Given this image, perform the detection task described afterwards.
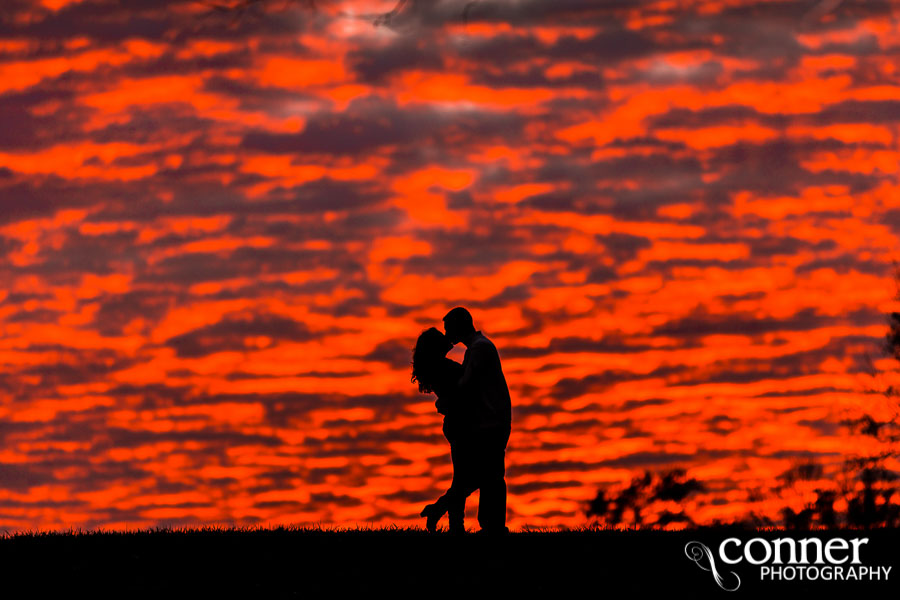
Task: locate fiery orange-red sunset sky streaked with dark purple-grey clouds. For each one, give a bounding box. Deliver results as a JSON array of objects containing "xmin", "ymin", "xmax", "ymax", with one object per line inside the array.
[{"xmin": 0, "ymin": 0, "xmax": 900, "ymax": 531}]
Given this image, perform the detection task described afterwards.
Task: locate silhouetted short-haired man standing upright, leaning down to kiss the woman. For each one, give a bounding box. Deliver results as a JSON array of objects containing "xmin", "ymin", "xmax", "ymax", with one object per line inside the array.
[{"xmin": 444, "ymin": 306, "xmax": 512, "ymax": 534}]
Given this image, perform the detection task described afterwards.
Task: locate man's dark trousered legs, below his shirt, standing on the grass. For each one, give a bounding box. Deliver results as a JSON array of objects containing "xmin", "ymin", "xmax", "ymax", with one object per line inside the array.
[{"xmin": 478, "ymin": 430, "xmax": 509, "ymax": 532}]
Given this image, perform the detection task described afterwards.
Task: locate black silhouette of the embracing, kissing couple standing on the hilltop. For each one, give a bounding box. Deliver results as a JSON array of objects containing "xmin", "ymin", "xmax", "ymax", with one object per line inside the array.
[{"xmin": 412, "ymin": 306, "xmax": 512, "ymax": 534}]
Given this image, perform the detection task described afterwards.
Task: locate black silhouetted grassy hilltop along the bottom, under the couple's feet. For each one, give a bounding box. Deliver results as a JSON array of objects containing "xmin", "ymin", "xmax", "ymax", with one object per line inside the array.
[{"xmin": 0, "ymin": 527, "xmax": 900, "ymax": 598}]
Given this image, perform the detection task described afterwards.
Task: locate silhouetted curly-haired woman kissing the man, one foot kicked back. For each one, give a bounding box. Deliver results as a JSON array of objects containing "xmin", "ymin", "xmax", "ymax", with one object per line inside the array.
[{"xmin": 411, "ymin": 327, "xmax": 474, "ymax": 533}]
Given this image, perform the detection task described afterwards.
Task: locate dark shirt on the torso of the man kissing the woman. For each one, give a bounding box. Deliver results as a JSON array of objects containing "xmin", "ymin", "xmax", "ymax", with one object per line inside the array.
[{"xmin": 459, "ymin": 331, "xmax": 512, "ymax": 428}]
